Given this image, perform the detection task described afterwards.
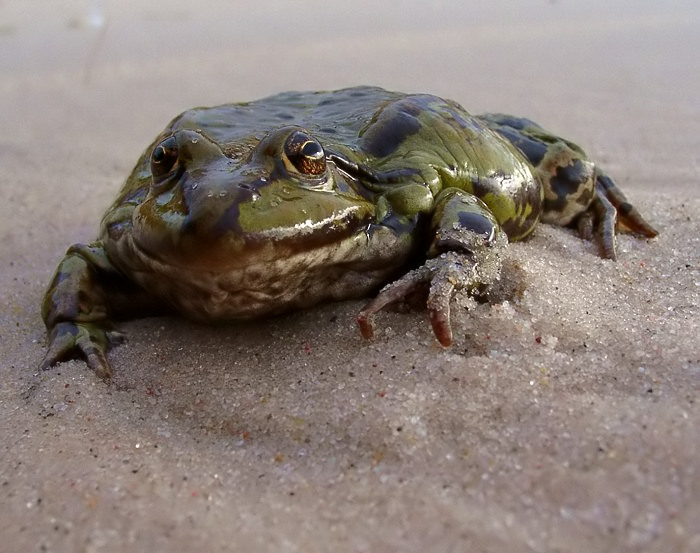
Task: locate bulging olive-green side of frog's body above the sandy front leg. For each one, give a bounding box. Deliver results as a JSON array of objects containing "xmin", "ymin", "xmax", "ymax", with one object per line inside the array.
[{"xmin": 340, "ymin": 90, "xmax": 543, "ymax": 240}]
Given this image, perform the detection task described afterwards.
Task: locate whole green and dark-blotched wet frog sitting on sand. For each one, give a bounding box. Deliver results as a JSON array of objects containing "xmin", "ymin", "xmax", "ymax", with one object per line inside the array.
[{"xmin": 41, "ymin": 86, "xmax": 657, "ymax": 379}]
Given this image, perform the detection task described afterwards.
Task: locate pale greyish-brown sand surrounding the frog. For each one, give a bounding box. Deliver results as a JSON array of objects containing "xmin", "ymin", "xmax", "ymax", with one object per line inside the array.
[{"xmin": 0, "ymin": 0, "xmax": 700, "ymax": 552}]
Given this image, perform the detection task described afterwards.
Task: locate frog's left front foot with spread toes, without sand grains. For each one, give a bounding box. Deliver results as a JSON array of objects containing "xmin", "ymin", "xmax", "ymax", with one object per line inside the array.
[{"xmin": 41, "ymin": 321, "xmax": 124, "ymax": 379}]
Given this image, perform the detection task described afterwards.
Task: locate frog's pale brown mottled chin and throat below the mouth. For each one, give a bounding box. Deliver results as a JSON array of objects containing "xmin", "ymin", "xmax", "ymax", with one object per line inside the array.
[{"xmin": 124, "ymin": 226, "xmax": 405, "ymax": 322}]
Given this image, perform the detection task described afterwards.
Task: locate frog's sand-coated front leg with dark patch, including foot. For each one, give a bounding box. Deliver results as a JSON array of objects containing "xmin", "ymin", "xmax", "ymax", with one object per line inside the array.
[{"xmin": 357, "ymin": 188, "xmax": 508, "ymax": 346}]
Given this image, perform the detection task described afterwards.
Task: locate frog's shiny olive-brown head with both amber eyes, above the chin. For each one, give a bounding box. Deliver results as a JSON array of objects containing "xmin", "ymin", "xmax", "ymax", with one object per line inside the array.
[{"xmin": 133, "ymin": 126, "xmax": 374, "ymax": 268}]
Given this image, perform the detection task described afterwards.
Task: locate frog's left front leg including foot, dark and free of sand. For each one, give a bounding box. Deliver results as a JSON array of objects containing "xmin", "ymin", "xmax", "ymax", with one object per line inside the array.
[{"xmin": 41, "ymin": 241, "xmax": 155, "ymax": 378}]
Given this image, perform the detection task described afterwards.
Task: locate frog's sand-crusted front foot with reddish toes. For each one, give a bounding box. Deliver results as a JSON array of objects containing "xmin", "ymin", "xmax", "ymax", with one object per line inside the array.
[{"xmin": 357, "ymin": 239, "xmax": 505, "ymax": 347}]
